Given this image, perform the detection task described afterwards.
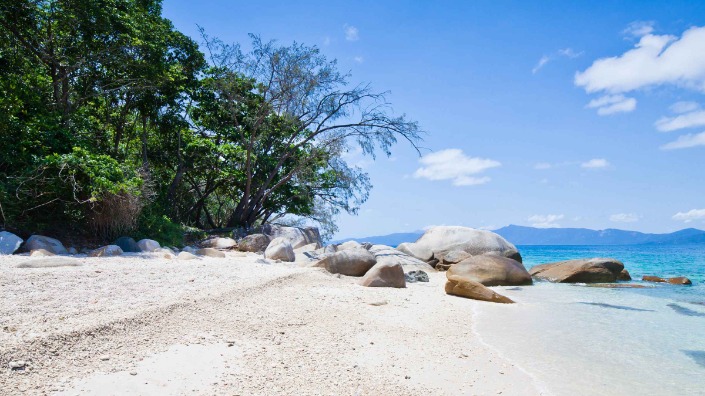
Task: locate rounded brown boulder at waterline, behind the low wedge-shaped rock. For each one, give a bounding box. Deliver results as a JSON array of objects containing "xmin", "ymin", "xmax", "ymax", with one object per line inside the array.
[{"xmin": 446, "ymin": 255, "xmax": 532, "ymax": 286}]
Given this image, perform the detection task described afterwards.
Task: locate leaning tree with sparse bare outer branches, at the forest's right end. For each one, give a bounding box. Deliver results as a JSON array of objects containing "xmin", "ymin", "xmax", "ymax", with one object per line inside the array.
[{"xmin": 188, "ymin": 30, "xmax": 421, "ymax": 232}]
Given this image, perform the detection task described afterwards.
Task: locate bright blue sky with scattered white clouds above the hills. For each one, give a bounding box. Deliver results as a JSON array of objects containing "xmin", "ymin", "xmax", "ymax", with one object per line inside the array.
[{"xmin": 164, "ymin": 0, "xmax": 705, "ymax": 238}]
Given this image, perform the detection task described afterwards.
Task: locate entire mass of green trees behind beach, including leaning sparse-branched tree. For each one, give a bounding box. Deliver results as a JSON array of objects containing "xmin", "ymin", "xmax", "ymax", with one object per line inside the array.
[{"xmin": 0, "ymin": 0, "xmax": 421, "ymax": 245}]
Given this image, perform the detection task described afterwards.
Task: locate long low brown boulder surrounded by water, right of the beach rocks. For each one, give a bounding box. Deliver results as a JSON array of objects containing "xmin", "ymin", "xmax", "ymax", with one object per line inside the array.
[{"xmin": 529, "ymin": 258, "xmax": 624, "ymax": 283}]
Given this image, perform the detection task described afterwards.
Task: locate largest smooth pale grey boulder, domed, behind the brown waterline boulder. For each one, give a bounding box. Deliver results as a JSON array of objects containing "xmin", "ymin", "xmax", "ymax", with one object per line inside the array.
[{"xmin": 397, "ymin": 226, "xmax": 521, "ymax": 262}]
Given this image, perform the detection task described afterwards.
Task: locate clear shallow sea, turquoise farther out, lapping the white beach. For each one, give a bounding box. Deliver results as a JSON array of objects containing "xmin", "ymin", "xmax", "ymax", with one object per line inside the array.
[{"xmin": 473, "ymin": 245, "xmax": 705, "ymax": 395}]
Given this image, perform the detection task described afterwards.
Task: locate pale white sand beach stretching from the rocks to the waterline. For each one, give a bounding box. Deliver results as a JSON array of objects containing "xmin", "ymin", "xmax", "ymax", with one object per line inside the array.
[{"xmin": 0, "ymin": 254, "xmax": 540, "ymax": 396}]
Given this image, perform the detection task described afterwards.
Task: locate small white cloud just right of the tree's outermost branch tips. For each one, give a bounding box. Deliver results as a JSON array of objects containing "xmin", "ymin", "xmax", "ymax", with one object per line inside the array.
[{"xmin": 414, "ymin": 149, "xmax": 502, "ymax": 186}]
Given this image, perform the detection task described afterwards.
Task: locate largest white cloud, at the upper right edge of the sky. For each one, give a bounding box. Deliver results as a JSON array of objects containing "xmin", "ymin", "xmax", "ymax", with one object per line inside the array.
[{"xmin": 575, "ymin": 27, "xmax": 705, "ymax": 94}]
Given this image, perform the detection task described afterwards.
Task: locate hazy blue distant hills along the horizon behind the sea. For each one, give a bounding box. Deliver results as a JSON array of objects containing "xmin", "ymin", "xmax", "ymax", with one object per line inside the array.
[{"xmin": 334, "ymin": 225, "xmax": 705, "ymax": 246}]
